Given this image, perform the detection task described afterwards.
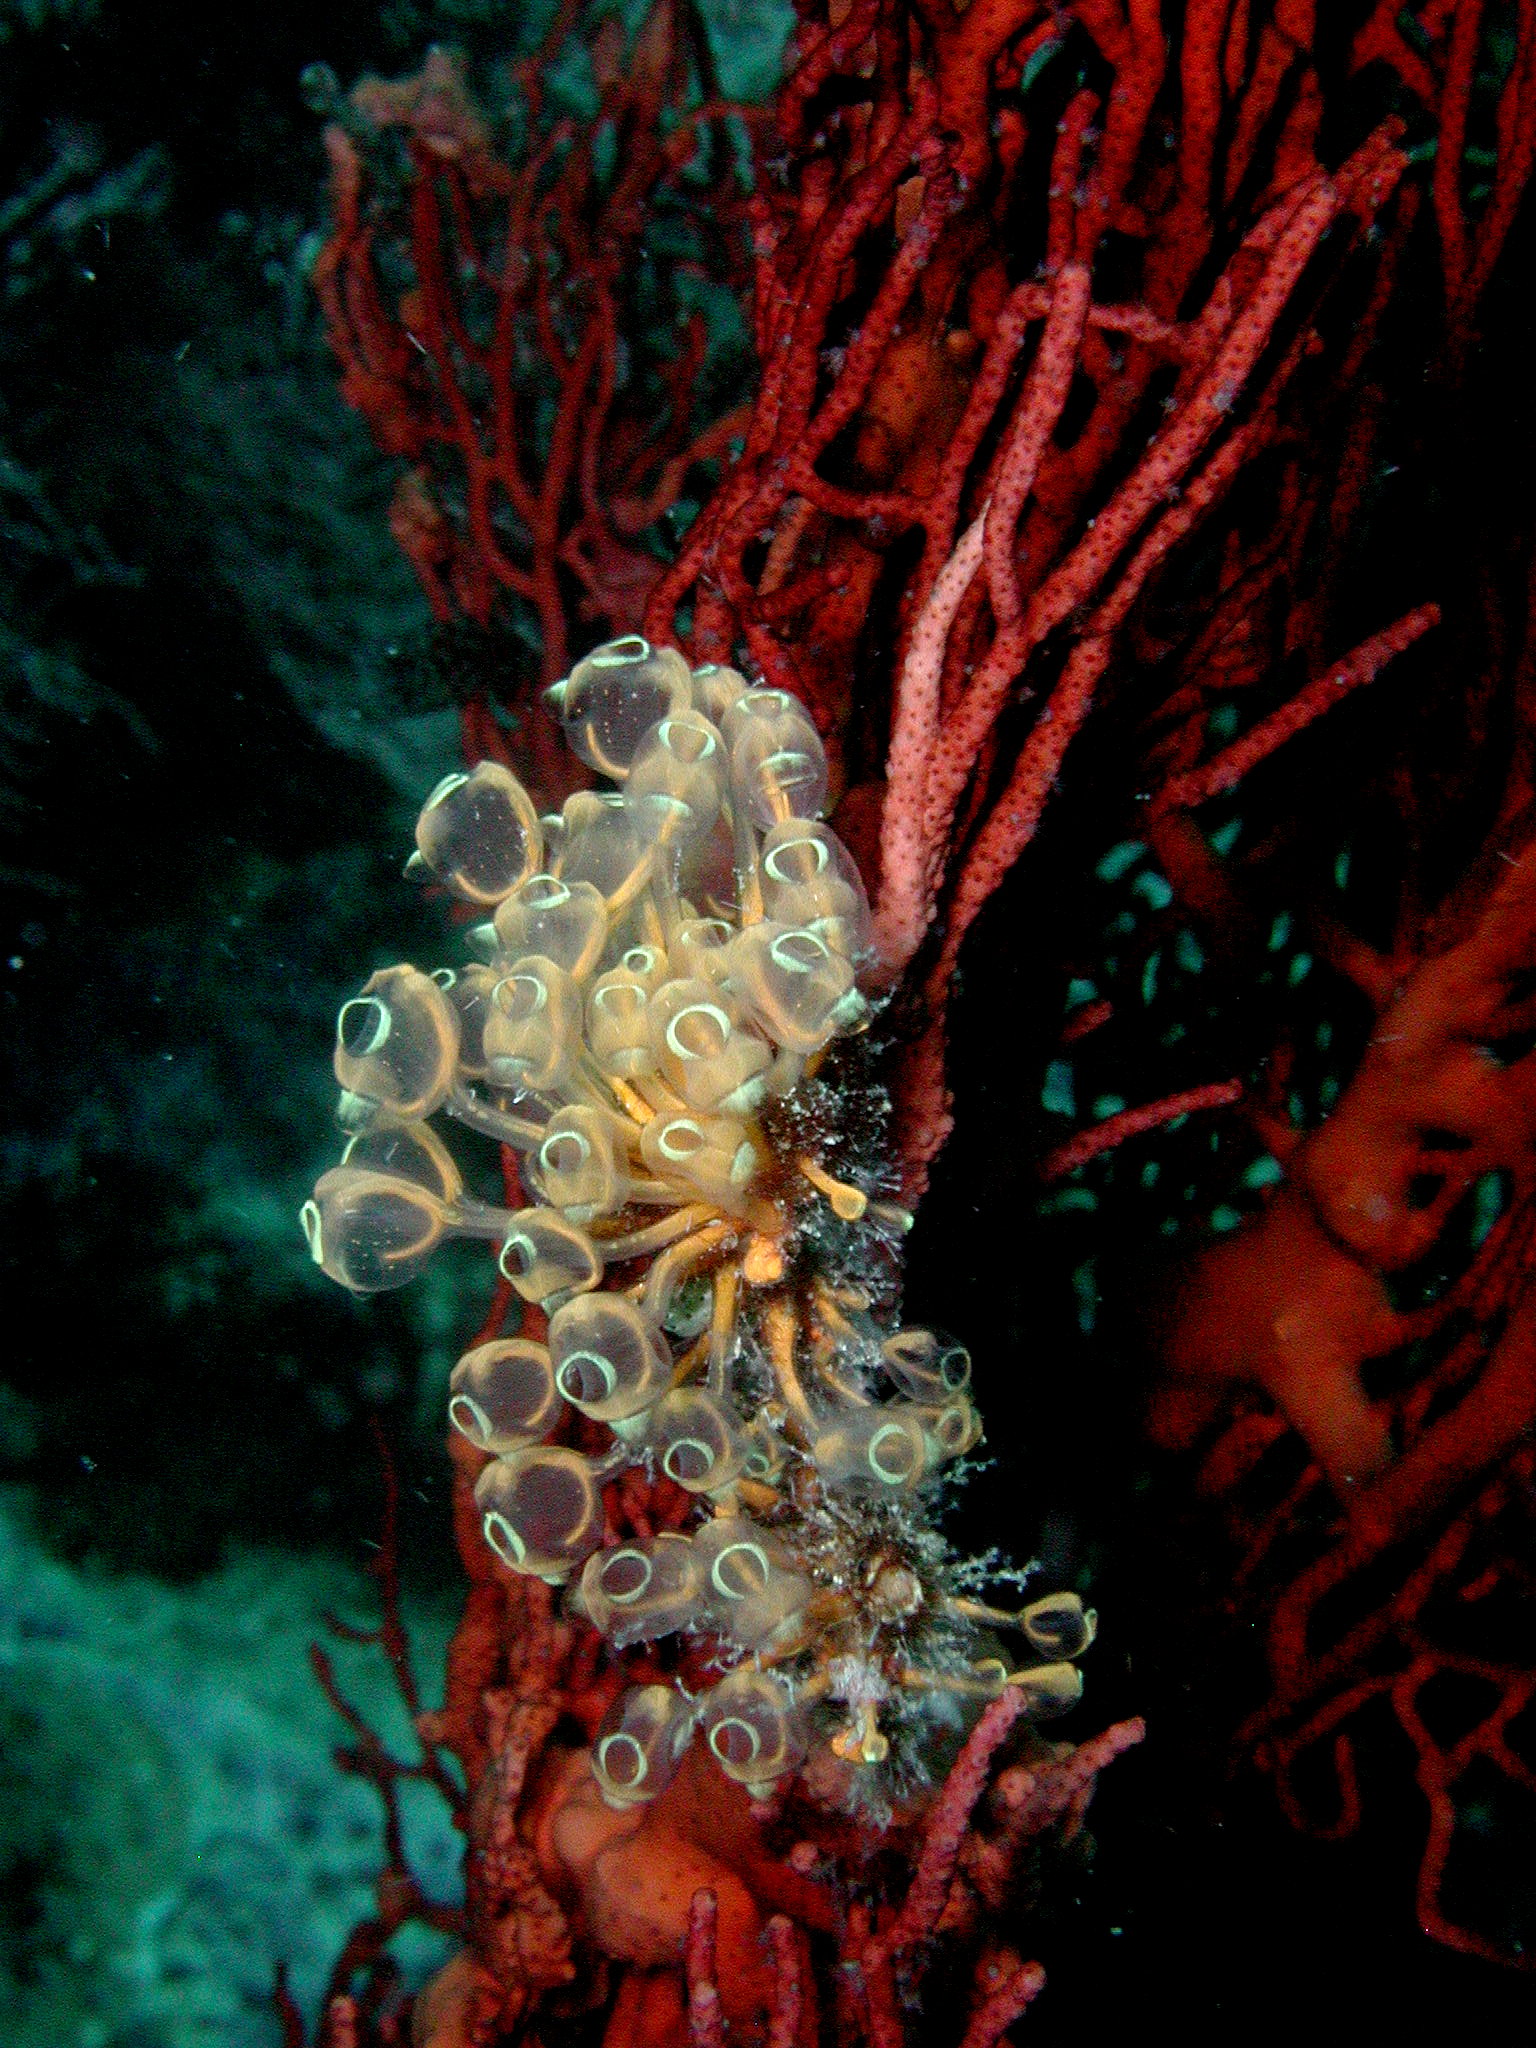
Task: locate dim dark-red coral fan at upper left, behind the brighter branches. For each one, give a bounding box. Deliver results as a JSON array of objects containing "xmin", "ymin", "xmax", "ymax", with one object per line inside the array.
[{"xmin": 315, "ymin": 22, "xmax": 754, "ymax": 788}]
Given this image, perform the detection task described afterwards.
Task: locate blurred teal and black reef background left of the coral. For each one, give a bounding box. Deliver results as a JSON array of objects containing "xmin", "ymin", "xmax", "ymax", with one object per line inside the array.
[{"xmin": 0, "ymin": 0, "xmax": 786, "ymax": 2048}]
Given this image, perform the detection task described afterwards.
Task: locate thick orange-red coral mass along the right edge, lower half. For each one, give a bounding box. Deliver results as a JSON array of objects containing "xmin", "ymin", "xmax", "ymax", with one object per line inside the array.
[{"xmin": 1153, "ymin": 761, "xmax": 1536, "ymax": 1960}]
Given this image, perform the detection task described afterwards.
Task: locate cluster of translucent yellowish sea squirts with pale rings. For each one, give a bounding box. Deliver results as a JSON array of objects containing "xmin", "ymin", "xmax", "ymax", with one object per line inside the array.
[{"xmin": 303, "ymin": 637, "xmax": 1094, "ymax": 1806}]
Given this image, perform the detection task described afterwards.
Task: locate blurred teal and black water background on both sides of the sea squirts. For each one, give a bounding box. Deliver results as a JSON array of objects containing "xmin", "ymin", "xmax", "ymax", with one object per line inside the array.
[{"xmin": 0, "ymin": 0, "xmax": 1536, "ymax": 2048}]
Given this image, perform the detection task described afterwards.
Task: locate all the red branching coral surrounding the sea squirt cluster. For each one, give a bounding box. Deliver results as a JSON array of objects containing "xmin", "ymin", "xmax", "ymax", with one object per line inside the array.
[{"xmin": 303, "ymin": 0, "xmax": 1536, "ymax": 2023}]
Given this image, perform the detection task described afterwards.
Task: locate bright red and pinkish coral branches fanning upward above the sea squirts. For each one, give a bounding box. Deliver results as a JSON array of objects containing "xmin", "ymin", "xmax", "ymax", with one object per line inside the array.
[{"xmin": 647, "ymin": 6, "xmax": 1466, "ymax": 1194}]
